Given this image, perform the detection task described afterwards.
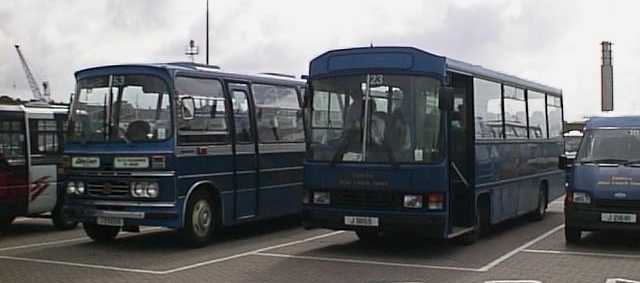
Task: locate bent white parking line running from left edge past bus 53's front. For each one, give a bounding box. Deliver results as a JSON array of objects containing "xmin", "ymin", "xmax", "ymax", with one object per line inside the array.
[{"xmin": 0, "ymin": 231, "xmax": 344, "ymax": 275}]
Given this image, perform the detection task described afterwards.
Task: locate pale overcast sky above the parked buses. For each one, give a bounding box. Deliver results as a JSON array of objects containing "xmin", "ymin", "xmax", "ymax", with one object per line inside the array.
[{"xmin": 0, "ymin": 0, "xmax": 640, "ymax": 120}]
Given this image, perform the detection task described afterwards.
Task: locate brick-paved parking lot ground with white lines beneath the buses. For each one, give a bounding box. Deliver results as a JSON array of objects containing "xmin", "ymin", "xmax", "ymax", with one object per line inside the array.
[{"xmin": 0, "ymin": 201, "xmax": 640, "ymax": 283}]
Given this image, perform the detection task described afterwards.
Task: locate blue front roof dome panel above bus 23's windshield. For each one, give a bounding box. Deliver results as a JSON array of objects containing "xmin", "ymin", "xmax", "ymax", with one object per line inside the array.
[{"xmin": 309, "ymin": 47, "xmax": 446, "ymax": 80}]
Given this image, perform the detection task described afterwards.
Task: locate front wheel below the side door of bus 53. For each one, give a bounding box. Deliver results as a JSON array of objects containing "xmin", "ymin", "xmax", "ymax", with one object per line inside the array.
[{"xmin": 180, "ymin": 191, "xmax": 217, "ymax": 247}]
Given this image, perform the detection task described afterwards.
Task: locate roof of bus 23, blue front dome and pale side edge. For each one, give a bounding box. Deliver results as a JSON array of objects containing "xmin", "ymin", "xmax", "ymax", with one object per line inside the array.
[{"xmin": 309, "ymin": 47, "xmax": 562, "ymax": 95}]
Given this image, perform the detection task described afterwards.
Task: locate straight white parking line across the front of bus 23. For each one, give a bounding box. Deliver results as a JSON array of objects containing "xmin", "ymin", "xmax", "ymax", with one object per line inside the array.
[{"xmin": 254, "ymin": 253, "xmax": 482, "ymax": 272}]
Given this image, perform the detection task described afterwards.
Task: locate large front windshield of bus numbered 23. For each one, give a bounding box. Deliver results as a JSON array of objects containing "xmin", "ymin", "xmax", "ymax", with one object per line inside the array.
[{"xmin": 309, "ymin": 74, "xmax": 443, "ymax": 163}]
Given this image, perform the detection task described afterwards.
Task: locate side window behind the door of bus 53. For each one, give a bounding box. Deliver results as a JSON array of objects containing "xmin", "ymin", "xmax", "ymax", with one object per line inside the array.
[{"xmin": 252, "ymin": 84, "xmax": 304, "ymax": 143}]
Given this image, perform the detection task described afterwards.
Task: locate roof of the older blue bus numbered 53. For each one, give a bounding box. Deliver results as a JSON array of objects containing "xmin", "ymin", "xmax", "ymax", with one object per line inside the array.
[{"xmin": 75, "ymin": 62, "xmax": 305, "ymax": 84}]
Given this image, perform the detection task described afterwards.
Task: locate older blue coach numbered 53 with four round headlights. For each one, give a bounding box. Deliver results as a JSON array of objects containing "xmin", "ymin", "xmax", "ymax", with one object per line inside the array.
[{"xmin": 64, "ymin": 63, "xmax": 305, "ymax": 246}]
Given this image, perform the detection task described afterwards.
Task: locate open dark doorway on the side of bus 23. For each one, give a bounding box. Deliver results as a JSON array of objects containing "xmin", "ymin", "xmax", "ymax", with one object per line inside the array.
[{"xmin": 448, "ymin": 74, "xmax": 475, "ymax": 231}]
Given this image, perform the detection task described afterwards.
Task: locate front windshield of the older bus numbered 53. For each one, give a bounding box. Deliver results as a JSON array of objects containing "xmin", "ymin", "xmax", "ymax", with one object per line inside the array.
[{"xmin": 68, "ymin": 75, "xmax": 172, "ymax": 143}]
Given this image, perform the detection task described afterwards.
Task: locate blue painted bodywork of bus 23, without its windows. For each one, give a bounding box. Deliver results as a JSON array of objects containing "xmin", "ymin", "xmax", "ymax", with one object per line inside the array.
[{"xmin": 303, "ymin": 47, "xmax": 564, "ymax": 237}]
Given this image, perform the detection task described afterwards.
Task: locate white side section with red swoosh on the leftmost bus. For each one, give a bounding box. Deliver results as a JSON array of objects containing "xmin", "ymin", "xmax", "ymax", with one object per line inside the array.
[{"xmin": 27, "ymin": 112, "xmax": 62, "ymax": 214}]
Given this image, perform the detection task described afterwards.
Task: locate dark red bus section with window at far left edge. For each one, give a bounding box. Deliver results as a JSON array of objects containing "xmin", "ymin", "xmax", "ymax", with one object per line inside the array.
[{"xmin": 0, "ymin": 110, "xmax": 29, "ymax": 216}]
